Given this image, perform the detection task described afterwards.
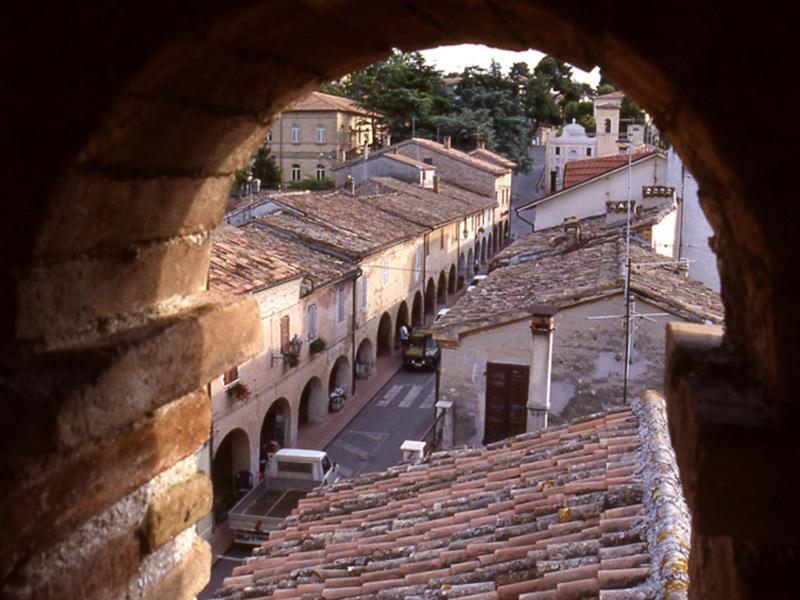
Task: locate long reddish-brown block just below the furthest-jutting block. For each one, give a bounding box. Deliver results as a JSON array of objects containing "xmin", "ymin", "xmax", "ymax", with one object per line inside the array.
[{"xmin": 0, "ymin": 392, "xmax": 211, "ymax": 575}]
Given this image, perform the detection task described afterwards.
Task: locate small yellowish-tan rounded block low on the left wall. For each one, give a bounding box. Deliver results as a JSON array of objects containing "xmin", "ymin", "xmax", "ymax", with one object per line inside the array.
[{"xmin": 140, "ymin": 473, "xmax": 213, "ymax": 552}]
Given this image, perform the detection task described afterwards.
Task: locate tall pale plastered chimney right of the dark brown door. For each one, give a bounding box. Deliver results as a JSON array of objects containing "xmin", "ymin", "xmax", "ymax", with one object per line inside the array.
[{"xmin": 527, "ymin": 306, "xmax": 557, "ymax": 432}]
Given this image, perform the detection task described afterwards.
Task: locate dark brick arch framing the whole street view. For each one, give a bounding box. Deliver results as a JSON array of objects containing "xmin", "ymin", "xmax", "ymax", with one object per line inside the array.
[{"xmin": 0, "ymin": 0, "xmax": 800, "ymax": 595}]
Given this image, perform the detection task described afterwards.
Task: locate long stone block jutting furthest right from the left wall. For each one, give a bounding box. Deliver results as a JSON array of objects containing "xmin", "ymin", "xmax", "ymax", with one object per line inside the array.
[{"xmin": 0, "ymin": 293, "xmax": 263, "ymax": 465}]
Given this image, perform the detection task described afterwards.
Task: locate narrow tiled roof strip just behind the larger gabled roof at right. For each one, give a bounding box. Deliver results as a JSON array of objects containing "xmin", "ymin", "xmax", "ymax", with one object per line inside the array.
[{"xmin": 492, "ymin": 203, "xmax": 676, "ymax": 266}]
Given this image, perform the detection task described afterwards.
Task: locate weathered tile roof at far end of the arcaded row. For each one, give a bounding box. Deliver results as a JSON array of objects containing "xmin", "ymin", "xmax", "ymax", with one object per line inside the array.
[{"xmin": 358, "ymin": 177, "xmax": 496, "ymax": 227}]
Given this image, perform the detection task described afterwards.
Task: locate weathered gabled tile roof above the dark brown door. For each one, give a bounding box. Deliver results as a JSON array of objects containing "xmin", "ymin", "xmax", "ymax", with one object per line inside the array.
[{"xmin": 433, "ymin": 238, "xmax": 724, "ymax": 339}]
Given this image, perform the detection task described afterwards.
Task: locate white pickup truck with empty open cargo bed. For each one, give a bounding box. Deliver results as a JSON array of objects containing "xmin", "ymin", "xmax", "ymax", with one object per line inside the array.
[{"xmin": 228, "ymin": 448, "xmax": 339, "ymax": 545}]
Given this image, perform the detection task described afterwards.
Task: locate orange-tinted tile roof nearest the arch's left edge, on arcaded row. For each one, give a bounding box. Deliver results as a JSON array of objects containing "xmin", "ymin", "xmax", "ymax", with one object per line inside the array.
[{"xmin": 208, "ymin": 224, "xmax": 303, "ymax": 294}]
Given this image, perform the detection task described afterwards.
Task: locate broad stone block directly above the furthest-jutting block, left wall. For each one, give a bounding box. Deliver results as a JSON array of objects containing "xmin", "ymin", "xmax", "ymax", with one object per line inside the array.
[{"xmin": 16, "ymin": 234, "xmax": 211, "ymax": 340}]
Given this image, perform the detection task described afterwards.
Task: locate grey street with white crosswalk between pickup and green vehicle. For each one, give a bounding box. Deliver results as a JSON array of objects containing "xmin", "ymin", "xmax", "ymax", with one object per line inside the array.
[{"xmin": 326, "ymin": 369, "xmax": 436, "ymax": 477}]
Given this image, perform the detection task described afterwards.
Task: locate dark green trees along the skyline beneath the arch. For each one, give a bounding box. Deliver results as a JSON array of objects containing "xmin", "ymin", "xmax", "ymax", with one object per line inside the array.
[{"xmin": 324, "ymin": 51, "xmax": 624, "ymax": 173}]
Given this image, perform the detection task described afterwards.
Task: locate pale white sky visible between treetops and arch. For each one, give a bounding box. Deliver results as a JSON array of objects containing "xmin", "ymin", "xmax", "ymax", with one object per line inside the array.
[{"xmin": 421, "ymin": 44, "xmax": 600, "ymax": 87}]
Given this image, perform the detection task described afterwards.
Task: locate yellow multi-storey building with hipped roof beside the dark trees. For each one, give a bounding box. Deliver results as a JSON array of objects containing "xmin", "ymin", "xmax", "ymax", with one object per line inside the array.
[{"xmin": 267, "ymin": 92, "xmax": 379, "ymax": 182}]
